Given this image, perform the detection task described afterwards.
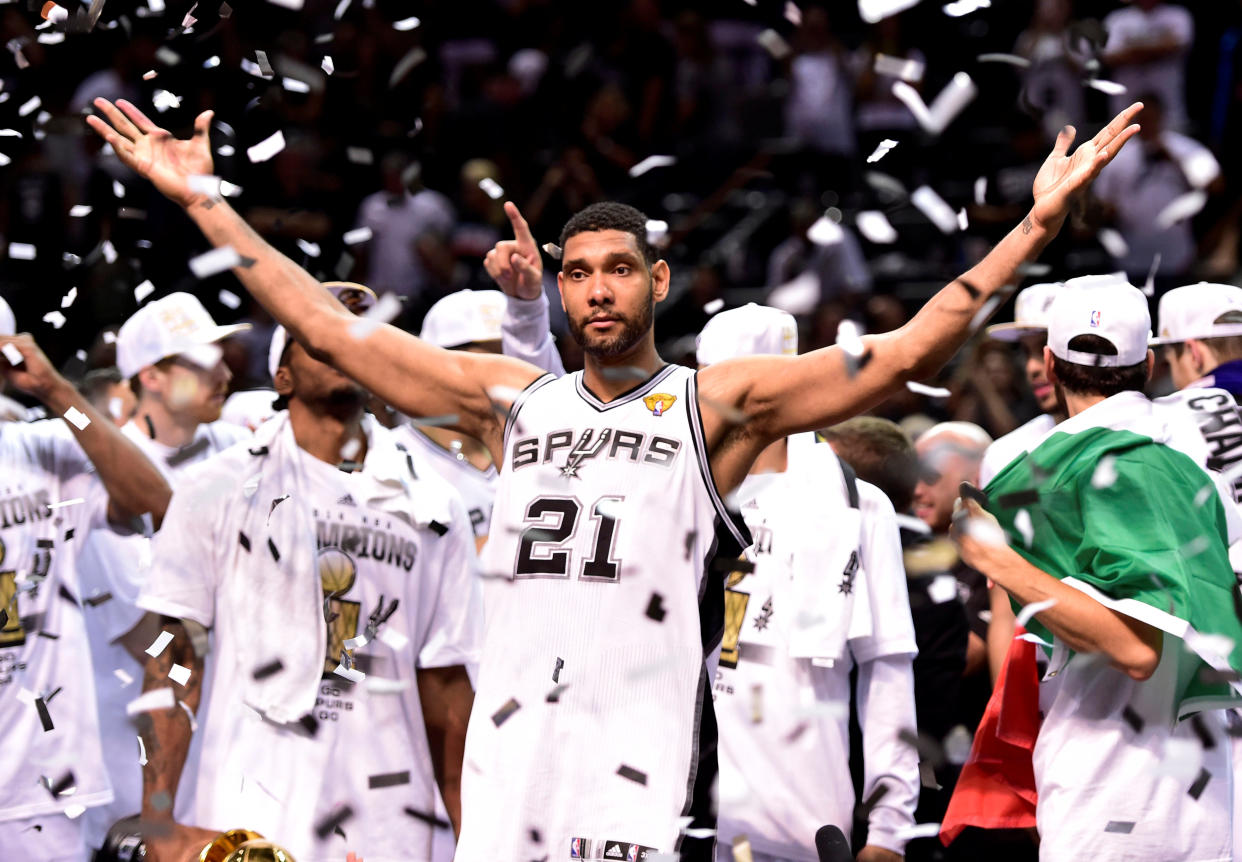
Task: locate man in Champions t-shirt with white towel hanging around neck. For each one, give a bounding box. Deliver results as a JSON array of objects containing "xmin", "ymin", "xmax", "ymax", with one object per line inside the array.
[{"xmin": 138, "ymin": 320, "xmax": 482, "ymax": 862}]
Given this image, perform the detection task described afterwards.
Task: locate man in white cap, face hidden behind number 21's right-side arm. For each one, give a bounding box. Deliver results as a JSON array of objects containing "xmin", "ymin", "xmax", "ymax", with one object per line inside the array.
[{"xmin": 698, "ymin": 304, "xmax": 919, "ymax": 862}]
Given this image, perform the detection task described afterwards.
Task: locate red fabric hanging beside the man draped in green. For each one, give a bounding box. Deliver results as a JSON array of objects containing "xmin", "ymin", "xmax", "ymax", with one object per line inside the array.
[{"xmin": 940, "ymin": 626, "xmax": 1040, "ymax": 847}]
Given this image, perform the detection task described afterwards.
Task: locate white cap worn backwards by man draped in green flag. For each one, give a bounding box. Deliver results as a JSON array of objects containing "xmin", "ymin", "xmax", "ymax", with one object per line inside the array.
[{"xmin": 1048, "ymin": 276, "xmax": 1151, "ymax": 368}]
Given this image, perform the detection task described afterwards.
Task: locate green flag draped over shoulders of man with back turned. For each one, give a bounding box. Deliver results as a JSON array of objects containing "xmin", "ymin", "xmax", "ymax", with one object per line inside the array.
[{"xmin": 986, "ymin": 424, "xmax": 1242, "ymax": 717}]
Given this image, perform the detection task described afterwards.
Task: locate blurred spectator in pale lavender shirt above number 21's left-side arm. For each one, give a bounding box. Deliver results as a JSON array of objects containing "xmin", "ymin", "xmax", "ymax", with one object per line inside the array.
[{"xmin": 356, "ymin": 153, "xmax": 456, "ymax": 315}]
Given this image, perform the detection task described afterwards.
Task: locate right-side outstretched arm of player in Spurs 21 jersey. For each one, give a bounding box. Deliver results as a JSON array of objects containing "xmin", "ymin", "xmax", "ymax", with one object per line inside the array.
[{"xmin": 699, "ymin": 102, "xmax": 1143, "ymax": 492}]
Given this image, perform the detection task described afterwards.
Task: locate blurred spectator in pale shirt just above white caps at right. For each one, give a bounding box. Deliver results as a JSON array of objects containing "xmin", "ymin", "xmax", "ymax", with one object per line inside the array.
[{"xmin": 1094, "ymin": 92, "xmax": 1223, "ymax": 284}]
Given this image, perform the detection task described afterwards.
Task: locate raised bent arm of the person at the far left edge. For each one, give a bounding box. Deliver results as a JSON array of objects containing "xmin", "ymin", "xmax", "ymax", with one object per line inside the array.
[{"xmin": 0, "ymin": 333, "xmax": 173, "ymax": 525}]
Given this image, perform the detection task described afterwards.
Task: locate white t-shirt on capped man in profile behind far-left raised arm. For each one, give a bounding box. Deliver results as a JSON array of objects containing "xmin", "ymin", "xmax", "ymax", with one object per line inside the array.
[{"xmin": 78, "ymin": 420, "xmax": 250, "ymax": 848}]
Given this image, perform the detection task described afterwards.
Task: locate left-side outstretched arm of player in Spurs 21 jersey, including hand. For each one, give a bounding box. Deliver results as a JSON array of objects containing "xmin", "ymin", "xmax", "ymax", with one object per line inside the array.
[{"xmin": 87, "ymin": 99, "xmax": 542, "ymax": 463}]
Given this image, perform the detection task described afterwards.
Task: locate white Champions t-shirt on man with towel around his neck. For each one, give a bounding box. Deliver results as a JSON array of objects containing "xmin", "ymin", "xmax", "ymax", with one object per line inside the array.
[{"xmin": 139, "ymin": 439, "xmax": 482, "ymax": 862}]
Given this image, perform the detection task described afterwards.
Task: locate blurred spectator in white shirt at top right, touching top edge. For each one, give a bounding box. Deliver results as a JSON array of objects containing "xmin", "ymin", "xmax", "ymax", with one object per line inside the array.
[{"xmin": 1104, "ymin": 0, "xmax": 1195, "ymax": 132}]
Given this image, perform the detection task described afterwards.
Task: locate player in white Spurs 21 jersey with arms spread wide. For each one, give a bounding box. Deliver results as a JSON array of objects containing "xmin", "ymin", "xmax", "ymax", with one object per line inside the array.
[{"xmin": 88, "ymin": 99, "xmax": 1141, "ymax": 862}]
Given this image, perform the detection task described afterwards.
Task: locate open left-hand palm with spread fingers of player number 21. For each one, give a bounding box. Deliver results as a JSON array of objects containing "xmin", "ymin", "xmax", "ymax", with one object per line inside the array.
[{"xmin": 86, "ymin": 98, "xmax": 215, "ymax": 209}]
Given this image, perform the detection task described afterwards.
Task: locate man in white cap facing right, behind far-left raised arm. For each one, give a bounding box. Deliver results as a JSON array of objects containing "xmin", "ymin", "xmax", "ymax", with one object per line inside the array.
[{"xmin": 79, "ymin": 292, "xmax": 250, "ymax": 848}]
